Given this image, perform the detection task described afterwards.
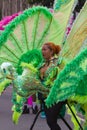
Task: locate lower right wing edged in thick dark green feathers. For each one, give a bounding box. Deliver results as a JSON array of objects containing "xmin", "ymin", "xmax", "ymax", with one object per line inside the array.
[{"xmin": 46, "ymin": 49, "xmax": 87, "ymax": 106}]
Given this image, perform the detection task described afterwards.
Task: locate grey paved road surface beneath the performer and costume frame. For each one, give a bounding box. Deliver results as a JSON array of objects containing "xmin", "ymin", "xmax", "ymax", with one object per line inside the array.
[{"xmin": 0, "ymin": 88, "xmax": 73, "ymax": 130}]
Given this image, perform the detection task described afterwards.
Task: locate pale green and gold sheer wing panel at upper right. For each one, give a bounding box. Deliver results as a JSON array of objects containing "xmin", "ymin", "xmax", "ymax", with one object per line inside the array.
[{"xmin": 62, "ymin": 2, "xmax": 87, "ymax": 61}]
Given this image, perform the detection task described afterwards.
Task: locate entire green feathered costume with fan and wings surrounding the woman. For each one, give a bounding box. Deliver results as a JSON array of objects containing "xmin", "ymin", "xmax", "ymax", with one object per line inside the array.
[{"xmin": 0, "ymin": 0, "xmax": 87, "ymax": 129}]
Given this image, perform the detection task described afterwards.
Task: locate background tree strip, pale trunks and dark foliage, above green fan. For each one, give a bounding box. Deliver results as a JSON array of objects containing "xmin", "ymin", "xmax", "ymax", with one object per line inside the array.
[{"xmin": 0, "ymin": 0, "xmax": 54, "ymax": 17}]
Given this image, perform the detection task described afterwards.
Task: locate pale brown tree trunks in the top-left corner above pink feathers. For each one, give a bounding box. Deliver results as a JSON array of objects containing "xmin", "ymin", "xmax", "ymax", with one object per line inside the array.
[{"xmin": 0, "ymin": 0, "xmax": 29, "ymax": 17}]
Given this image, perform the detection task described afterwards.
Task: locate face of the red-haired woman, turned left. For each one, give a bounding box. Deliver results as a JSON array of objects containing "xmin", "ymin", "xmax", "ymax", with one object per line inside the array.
[{"xmin": 42, "ymin": 45, "xmax": 53, "ymax": 60}]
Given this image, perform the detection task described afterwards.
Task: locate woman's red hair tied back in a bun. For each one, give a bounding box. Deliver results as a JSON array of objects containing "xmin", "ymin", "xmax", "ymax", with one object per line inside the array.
[{"xmin": 44, "ymin": 42, "xmax": 61, "ymax": 55}]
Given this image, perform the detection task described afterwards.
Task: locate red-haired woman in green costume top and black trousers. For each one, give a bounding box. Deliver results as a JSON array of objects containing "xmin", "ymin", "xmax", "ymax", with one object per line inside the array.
[{"xmin": 38, "ymin": 42, "xmax": 66, "ymax": 130}]
